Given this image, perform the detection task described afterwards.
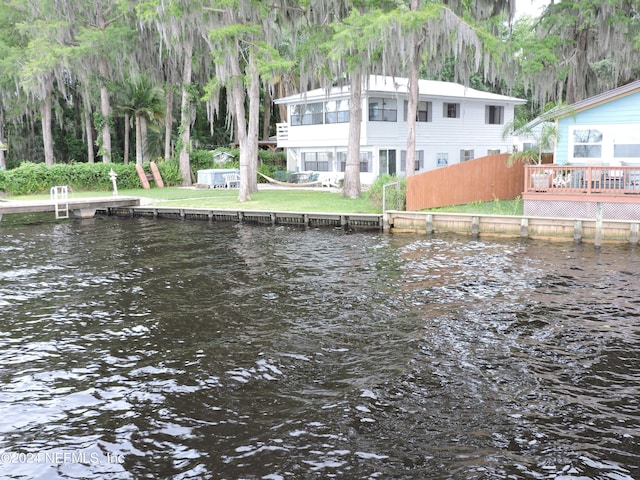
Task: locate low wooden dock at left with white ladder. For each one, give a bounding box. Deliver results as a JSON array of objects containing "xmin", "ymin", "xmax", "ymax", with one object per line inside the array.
[{"xmin": 0, "ymin": 196, "xmax": 140, "ymax": 220}]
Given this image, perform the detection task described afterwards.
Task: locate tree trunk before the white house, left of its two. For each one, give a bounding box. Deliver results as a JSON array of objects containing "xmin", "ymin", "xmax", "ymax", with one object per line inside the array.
[{"xmin": 342, "ymin": 73, "xmax": 362, "ymax": 198}]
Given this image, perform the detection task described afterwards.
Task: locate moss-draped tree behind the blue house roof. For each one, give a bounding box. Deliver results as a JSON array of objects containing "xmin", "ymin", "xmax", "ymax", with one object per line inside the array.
[{"xmin": 514, "ymin": 0, "xmax": 640, "ymax": 104}]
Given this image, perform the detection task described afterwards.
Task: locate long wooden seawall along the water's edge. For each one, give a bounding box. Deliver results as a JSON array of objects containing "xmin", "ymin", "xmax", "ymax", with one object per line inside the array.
[{"xmin": 102, "ymin": 206, "xmax": 640, "ymax": 246}]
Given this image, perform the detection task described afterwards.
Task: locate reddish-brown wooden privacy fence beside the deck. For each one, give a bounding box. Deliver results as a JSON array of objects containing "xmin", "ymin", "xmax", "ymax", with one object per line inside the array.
[{"xmin": 407, "ymin": 153, "xmax": 524, "ymax": 211}]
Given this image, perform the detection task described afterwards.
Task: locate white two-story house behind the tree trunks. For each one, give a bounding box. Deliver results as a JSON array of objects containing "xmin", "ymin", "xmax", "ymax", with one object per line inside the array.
[{"xmin": 276, "ymin": 75, "xmax": 525, "ymax": 185}]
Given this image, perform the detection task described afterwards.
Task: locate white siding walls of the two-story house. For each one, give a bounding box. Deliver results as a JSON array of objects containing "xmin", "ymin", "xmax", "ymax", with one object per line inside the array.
[{"xmin": 278, "ymin": 76, "xmax": 524, "ymax": 184}]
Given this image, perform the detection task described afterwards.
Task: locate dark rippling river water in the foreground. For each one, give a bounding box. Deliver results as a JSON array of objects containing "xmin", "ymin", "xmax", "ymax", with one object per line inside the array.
[{"xmin": 0, "ymin": 215, "xmax": 640, "ymax": 480}]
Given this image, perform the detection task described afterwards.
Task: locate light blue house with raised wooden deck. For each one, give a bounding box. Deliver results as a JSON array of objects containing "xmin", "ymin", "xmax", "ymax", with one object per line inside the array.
[{"xmin": 522, "ymin": 80, "xmax": 640, "ymax": 221}]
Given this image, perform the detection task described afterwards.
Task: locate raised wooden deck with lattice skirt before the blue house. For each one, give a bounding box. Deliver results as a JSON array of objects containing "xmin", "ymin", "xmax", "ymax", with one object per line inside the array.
[{"xmin": 522, "ymin": 164, "xmax": 640, "ymax": 220}]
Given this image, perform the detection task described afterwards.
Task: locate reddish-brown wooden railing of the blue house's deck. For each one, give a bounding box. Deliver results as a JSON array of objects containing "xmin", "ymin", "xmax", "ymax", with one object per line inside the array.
[{"xmin": 524, "ymin": 165, "xmax": 640, "ymax": 195}]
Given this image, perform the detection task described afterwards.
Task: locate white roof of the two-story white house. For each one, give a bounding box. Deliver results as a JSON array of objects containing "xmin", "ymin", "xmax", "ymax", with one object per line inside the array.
[{"xmin": 275, "ymin": 75, "xmax": 526, "ymax": 104}]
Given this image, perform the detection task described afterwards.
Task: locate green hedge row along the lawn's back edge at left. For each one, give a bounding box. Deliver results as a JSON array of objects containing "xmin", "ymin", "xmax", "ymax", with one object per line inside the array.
[{"xmin": 0, "ymin": 160, "xmax": 182, "ymax": 195}]
